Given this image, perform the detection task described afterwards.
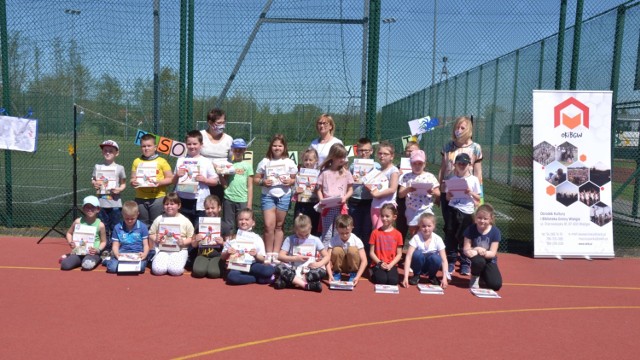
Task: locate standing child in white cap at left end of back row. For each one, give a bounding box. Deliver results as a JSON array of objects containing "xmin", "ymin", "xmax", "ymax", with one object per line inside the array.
[{"xmin": 91, "ymin": 140, "xmax": 127, "ymax": 246}]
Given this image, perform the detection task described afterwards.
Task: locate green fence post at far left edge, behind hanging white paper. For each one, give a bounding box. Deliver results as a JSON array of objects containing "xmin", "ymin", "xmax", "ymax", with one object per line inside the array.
[{"xmin": 0, "ymin": 0, "xmax": 13, "ymax": 227}]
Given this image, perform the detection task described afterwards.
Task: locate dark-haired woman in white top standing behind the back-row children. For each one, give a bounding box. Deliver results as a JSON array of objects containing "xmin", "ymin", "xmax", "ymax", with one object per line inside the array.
[{"xmin": 200, "ymin": 108, "xmax": 233, "ymax": 200}]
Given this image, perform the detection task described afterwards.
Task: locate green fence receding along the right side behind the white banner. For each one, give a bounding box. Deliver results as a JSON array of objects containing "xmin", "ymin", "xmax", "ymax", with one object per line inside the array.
[{"xmin": 381, "ymin": 2, "xmax": 640, "ymax": 255}]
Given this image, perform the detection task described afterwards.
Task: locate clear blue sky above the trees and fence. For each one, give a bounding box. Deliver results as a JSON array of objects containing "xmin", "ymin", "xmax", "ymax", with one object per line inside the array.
[{"xmin": 7, "ymin": 0, "xmax": 623, "ymax": 111}]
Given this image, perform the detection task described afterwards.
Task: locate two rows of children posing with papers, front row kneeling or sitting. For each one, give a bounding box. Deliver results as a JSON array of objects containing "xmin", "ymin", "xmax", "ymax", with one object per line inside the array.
[{"xmin": 61, "ymin": 131, "xmax": 502, "ymax": 292}]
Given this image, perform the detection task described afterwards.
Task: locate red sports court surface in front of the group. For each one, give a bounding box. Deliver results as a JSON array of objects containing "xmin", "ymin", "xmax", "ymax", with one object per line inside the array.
[{"xmin": 0, "ymin": 237, "xmax": 640, "ymax": 359}]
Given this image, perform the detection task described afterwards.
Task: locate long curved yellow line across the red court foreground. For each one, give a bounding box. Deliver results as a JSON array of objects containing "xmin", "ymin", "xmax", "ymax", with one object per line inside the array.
[{"xmin": 174, "ymin": 306, "xmax": 640, "ymax": 360}]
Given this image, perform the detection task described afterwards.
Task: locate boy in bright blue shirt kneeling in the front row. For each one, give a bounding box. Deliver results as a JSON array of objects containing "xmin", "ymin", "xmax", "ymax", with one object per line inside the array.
[{"xmin": 106, "ymin": 201, "xmax": 149, "ymax": 274}]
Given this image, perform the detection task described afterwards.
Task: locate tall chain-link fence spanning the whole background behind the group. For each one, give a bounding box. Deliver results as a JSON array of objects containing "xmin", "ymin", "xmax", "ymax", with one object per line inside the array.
[{"xmin": 0, "ymin": 0, "xmax": 638, "ymax": 256}]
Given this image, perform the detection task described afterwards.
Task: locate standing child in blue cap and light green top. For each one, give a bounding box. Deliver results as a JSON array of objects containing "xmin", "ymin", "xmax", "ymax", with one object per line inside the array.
[{"xmin": 220, "ymin": 138, "xmax": 254, "ymax": 230}]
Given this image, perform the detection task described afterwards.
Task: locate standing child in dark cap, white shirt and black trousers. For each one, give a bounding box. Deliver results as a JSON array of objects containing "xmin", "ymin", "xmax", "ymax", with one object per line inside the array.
[{"xmin": 445, "ymin": 153, "xmax": 480, "ymax": 277}]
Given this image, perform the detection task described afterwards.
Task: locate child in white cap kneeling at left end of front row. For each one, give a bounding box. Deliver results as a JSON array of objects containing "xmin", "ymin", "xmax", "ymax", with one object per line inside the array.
[{"xmin": 60, "ymin": 196, "xmax": 107, "ymax": 270}]
